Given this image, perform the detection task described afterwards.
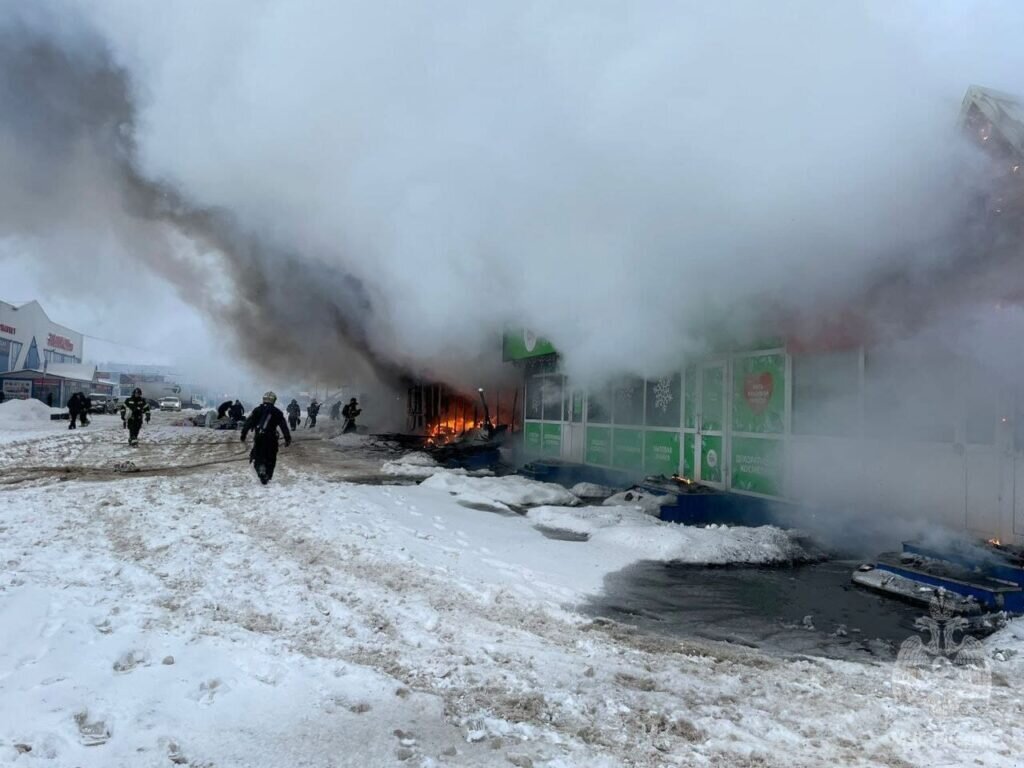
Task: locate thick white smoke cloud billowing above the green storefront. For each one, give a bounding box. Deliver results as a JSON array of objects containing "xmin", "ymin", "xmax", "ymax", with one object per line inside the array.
[{"xmin": 8, "ymin": 0, "xmax": 1024, "ymax": 385}]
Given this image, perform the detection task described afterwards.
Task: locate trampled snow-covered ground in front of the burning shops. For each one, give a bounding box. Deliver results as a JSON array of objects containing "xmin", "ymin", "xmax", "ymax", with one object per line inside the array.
[{"xmin": 0, "ymin": 423, "xmax": 1024, "ymax": 768}]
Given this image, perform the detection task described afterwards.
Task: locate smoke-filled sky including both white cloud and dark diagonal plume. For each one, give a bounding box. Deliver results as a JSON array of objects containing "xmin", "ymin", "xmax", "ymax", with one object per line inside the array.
[{"xmin": 0, "ymin": 0, "xmax": 1024, "ymax": 391}]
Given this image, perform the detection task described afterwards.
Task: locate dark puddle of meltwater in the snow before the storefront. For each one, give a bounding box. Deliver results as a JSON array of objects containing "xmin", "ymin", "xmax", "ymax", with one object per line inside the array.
[{"xmin": 583, "ymin": 560, "xmax": 942, "ymax": 659}]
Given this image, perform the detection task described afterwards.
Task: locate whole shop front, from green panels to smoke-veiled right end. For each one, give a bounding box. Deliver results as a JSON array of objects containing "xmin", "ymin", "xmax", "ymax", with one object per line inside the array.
[{"xmin": 505, "ymin": 335, "xmax": 1024, "ymax": 543}]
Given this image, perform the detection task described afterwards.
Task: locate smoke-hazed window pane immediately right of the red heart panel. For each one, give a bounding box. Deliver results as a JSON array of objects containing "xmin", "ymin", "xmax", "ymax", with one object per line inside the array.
[{"xmin": 793, "ymin": 349, "xmax": 860, "ymax": 437}]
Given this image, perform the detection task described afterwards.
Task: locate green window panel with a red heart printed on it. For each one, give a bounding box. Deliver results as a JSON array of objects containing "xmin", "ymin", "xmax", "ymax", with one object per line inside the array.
[{"xmin": 732, "ymin": 354, "xmax": 785, "ymax": 434}]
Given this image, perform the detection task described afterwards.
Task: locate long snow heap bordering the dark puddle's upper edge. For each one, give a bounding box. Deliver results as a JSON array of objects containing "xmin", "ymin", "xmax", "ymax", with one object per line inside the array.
[{"xmin": 526, "ymin": 506, "xmax": 810, "ymax": 565}]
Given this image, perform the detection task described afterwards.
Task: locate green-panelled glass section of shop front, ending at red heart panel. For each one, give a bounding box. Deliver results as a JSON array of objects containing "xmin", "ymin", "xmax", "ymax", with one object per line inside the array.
[{"xmin": 516, "ymin": 337, "xmax": 790, "ymax": 498}]
